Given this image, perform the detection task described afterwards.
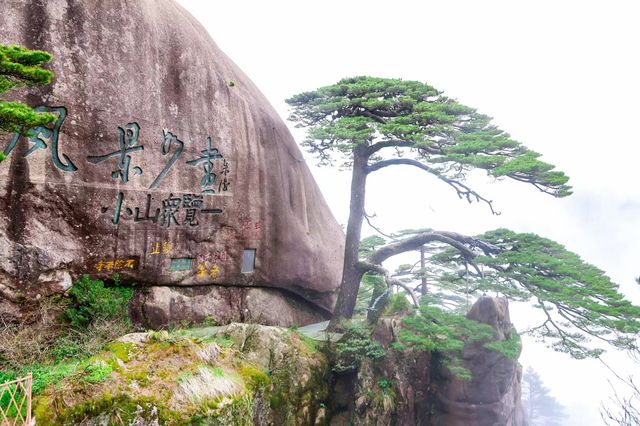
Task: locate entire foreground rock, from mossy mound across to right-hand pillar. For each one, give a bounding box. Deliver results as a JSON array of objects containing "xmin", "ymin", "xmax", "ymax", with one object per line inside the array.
[{"xmin": 16, "ymin": 298, "xmax": 525, "ymax": 426}]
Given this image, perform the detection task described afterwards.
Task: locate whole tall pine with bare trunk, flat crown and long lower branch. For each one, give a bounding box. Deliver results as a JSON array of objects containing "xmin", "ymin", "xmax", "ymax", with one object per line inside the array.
[{"xmin": 287, "ymin": 77, "xmax": 640, "ymax": 358}]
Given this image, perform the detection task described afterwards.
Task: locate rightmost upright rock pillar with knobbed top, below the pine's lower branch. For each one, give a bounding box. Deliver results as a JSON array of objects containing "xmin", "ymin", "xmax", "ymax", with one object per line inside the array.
[{"xmin": 434, "ymin": 297, "xmax": 525, "ymax": 426}]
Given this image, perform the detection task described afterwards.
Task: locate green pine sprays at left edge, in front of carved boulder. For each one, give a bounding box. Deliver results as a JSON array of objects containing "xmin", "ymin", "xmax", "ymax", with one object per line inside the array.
[{"xmin": 0, "ymin": 44, "xmax": 55, "ymax": 134}]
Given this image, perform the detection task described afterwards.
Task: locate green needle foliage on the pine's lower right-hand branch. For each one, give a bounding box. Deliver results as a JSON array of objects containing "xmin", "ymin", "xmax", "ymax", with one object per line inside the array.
[{"xmin": 430, "ymin": 229, "xmax": 640, "ymax": 358}]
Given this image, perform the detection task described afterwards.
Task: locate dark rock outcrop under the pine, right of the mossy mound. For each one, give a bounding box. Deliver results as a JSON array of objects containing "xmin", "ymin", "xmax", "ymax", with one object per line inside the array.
[{"xmin": 330, "ymin": 297, "xmax": 525, "ymax": 426}]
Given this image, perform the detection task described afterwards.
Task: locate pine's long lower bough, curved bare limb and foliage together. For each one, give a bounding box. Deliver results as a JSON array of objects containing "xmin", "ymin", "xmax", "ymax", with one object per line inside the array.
[{"xmin": 360, "ymin": 229, "xmax": 640, "ymax": 358}]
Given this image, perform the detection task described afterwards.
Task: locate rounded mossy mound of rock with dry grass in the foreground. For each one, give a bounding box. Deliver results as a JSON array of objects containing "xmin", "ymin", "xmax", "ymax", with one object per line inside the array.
[{"xmin": 34, "ymin": 324, "xmax": 329, "ymax": 426}]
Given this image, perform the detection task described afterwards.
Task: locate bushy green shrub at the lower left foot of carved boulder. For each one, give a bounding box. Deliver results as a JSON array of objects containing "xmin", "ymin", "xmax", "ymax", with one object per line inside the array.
[{"xmin": 64, "ymin": 275, "xmax": 133, "ymax": 328}]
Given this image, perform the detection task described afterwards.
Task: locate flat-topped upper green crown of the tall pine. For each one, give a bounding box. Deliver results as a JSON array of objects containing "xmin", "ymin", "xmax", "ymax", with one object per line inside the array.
[{"xmin": 287, "ymin": 77, "xmax": 571, "ymax": 197}]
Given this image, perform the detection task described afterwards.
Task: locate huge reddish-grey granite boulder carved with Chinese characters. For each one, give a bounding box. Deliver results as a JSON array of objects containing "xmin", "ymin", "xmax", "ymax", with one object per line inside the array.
[{"xmin": 0, "ymin": 0, "xmax": 344, "ymax": 321}]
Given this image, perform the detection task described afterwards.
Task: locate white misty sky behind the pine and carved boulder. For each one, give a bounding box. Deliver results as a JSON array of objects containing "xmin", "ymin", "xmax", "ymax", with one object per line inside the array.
[{"xmin": 180, "ymin": 0, "xmax": 640, "ymax": 426}]
